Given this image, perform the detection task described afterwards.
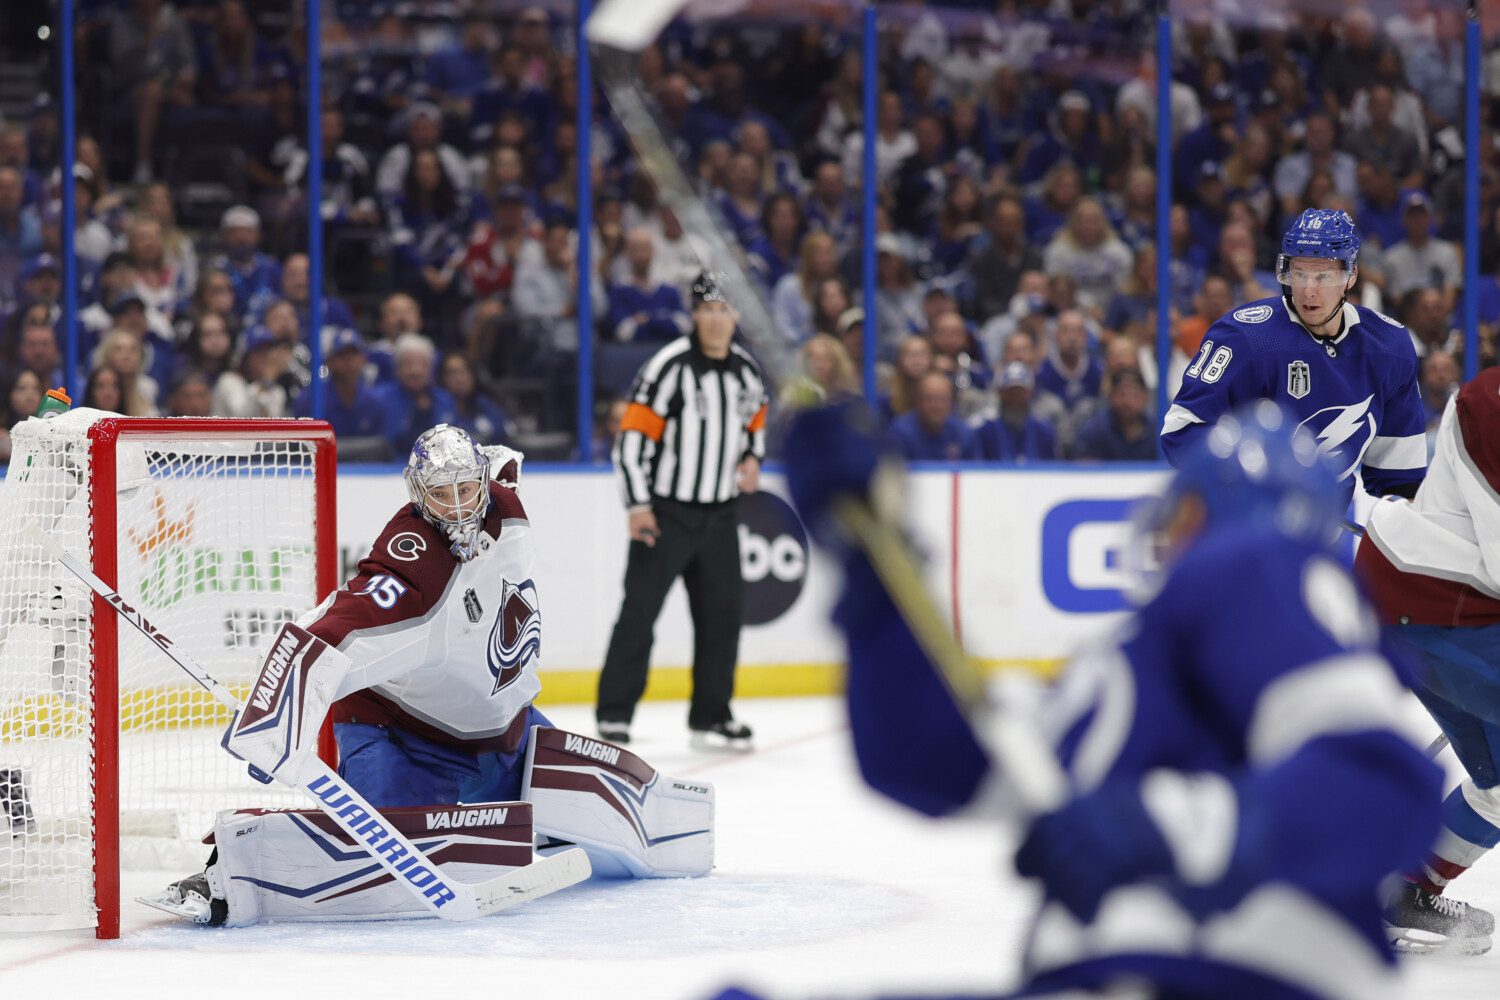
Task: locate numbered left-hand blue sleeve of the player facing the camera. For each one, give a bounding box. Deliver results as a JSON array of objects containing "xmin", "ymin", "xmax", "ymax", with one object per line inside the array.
[{"xmin": 1161, "ymin": 316, "xmax": 1271, "ymax": 463}]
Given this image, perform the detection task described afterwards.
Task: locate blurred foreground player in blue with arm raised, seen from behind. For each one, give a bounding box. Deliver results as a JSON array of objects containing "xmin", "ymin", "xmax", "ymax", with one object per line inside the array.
[{"xmin": 762, "ymin": 402, "xmax": 1440, "ymax": 1000}]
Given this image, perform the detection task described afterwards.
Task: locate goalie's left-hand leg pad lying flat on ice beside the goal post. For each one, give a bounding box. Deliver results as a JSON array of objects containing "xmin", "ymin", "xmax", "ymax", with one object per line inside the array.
[{"xmin": 209, "ymin": 802, "xmax": 533, "ymax": 927}]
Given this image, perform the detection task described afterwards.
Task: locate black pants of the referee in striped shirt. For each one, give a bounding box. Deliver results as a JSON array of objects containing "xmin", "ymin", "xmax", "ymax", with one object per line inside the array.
[{"xmin": 596, "ymin": 499, "xmax": 743, "ymax": 729}]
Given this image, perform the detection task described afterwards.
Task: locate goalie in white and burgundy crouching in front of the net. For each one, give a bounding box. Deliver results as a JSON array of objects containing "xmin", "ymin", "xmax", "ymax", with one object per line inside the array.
[{"xmin": 141, "ymin": 424, "xmax": 714, "ymax": 927}]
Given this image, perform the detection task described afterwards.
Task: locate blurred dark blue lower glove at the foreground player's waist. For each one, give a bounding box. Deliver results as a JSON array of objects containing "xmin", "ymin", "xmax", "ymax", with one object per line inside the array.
[{"xmin": 1016, "ymin": 780, "xmax": 1173, "ymax": 922}]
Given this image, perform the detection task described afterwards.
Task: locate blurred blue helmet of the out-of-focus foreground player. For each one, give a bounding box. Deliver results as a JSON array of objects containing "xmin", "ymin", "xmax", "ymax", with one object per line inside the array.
[{"xmin": 1163, "ymin": 399, "xmax": 1347, "ymax": 541}]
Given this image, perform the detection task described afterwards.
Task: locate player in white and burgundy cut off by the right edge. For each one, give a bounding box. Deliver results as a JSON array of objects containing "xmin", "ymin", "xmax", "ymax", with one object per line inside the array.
[{"xmin": 1356, "ymin": 369, "xmax": 1500, "ymax": 955}]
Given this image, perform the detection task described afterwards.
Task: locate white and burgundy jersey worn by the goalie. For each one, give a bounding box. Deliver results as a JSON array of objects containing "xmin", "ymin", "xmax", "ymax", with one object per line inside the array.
[{"xmin": 299, "ymin": 465, "xmax": 542, "ymax": 753}]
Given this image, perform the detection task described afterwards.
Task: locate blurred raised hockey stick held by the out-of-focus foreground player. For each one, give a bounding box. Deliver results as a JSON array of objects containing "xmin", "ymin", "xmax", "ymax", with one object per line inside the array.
[{"xmin": 585, "ymin": 0, "xmax": 1068, "ymax": 813}]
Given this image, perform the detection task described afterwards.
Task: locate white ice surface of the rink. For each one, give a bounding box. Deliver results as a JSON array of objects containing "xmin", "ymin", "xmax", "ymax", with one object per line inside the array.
[{"xmin": 0, "ymin": 699, "xmax": 1500, "ymax": 1000}]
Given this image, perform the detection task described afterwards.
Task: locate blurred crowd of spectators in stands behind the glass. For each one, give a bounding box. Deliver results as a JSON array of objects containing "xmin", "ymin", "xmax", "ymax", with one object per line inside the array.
[{"xmin": 0, "ymin": 0, "xmax": 1500, "ymax": 462}]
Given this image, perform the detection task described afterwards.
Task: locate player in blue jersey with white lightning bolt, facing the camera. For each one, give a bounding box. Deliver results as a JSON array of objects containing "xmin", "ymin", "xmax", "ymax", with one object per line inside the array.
[{"xmin": 1161, "ymin": 208, "xmax": 1427, "ymax": 498}]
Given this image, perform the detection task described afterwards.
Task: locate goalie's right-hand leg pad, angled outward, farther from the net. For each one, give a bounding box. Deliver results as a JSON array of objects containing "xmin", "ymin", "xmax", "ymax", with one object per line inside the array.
[{"xmin": 521, "ymin": 726, "xmax": 714, "ymax": 879}]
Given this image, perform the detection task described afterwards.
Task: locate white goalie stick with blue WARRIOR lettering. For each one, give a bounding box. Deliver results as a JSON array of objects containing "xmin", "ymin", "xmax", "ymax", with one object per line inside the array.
[{"xmin": 23, "ymin": 519, "xmax": 593, "ymax": 921}]
